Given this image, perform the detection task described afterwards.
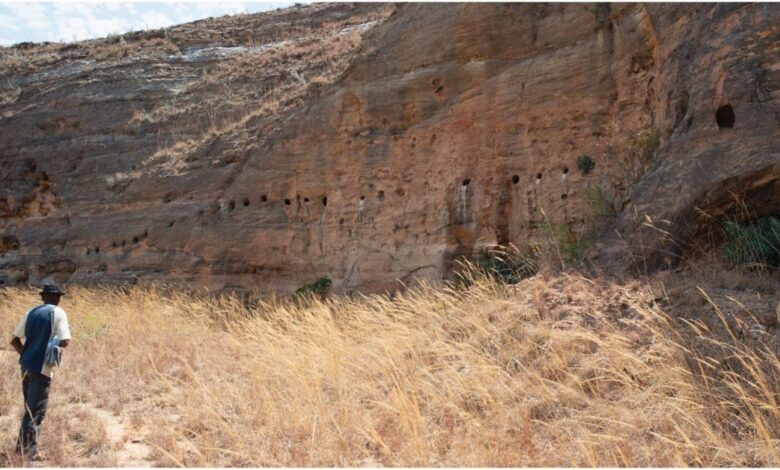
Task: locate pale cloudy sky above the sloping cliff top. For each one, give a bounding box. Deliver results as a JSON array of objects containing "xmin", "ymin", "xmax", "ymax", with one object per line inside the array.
[{"xmin": 0, "ymin": 0, "xmax": 298, "ymax": 46}]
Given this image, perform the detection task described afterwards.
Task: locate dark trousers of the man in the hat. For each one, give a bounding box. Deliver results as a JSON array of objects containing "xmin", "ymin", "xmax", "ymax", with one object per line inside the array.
[{"xmin": 16, "ymin": 370, "xmax": 51, "ymax": 458}]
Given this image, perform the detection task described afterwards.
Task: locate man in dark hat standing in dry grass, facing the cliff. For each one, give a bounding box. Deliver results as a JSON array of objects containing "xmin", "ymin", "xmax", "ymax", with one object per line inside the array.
[{"xmin": 11, "ymin": 285, "xmax": 70, "ymax": 459}]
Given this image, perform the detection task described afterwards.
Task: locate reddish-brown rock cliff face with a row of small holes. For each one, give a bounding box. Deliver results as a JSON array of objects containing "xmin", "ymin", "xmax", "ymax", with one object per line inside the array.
[{"xmin": 0, "ymin": 4, "xmax": 780, "ymax": 291}]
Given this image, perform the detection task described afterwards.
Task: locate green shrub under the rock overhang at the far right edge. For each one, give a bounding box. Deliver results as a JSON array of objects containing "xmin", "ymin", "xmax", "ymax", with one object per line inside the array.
[{"xmin": 720, "ymin": 217, "xmax": 780, "ymax": 268}]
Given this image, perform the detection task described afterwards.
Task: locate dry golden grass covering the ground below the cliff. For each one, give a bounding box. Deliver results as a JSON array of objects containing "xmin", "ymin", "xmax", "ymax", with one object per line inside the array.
[{"xmin": 0, "ymin": 275, "xmax": 780, "ymax": 466}]
